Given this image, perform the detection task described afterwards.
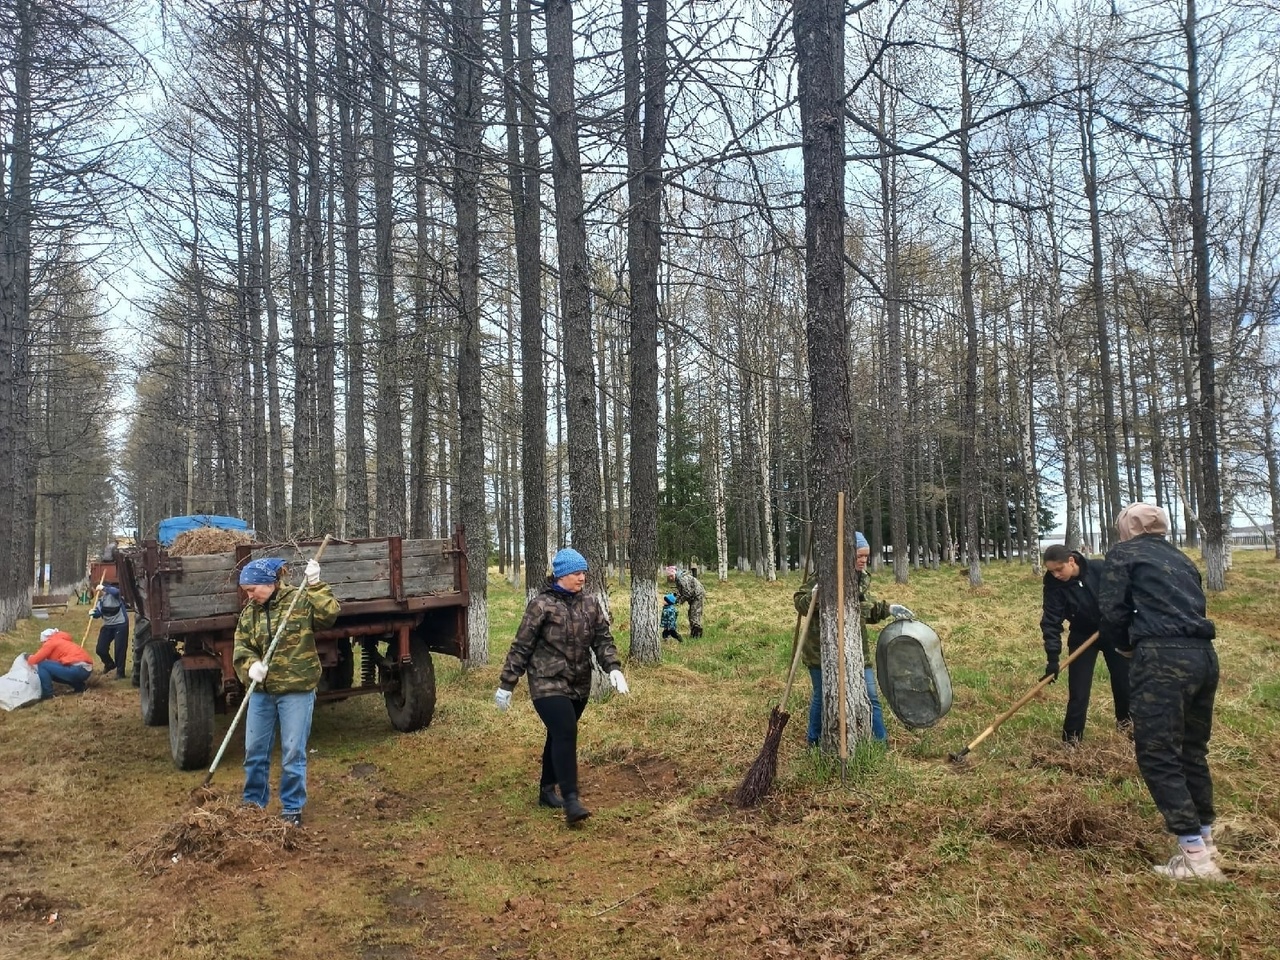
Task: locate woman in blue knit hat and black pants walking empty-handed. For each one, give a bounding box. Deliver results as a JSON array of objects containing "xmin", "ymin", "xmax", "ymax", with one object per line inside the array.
[{"xmin": 493, "ymin": 548, "xmax": 630, "ymax": 827}]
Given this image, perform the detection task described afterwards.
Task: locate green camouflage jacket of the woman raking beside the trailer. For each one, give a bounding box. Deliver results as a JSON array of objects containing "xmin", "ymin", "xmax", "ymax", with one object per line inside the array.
[{"xmin": 232, "ymin": 584, "xmax": 339, "ymax": 694}]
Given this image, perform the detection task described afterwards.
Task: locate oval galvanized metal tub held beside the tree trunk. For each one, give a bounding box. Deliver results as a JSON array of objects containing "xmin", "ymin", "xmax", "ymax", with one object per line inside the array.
[{"xmin": 876, "ymin": 620, "xmax": 951, "ymax": 730}]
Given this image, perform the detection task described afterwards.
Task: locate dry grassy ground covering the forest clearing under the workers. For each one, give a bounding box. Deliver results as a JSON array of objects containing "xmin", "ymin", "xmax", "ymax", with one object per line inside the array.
[{"xmin": 0, "ymin": 554, "xmax": 1280, "ymax": 960}]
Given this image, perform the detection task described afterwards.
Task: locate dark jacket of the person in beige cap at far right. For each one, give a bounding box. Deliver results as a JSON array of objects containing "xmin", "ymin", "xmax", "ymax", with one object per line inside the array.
[{"xmin": 1098, "ymin": 534, "xmax": 1215, "ymax": 648}]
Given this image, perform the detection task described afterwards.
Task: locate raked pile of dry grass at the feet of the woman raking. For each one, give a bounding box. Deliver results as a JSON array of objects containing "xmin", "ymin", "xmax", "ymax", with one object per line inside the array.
[{"xmin": 129, "ymin": 797, "xmax": 314, "ymax": 877}]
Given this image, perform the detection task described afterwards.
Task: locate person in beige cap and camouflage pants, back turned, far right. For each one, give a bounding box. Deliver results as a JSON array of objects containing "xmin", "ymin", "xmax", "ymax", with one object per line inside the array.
[{"xmin": 1098, "ymin": 503, "xmax": 1226, "ymax": 881}]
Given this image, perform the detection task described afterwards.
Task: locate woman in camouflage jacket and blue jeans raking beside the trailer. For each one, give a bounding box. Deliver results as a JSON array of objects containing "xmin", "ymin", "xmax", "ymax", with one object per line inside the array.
[{"xmin": 232, "ymin": 557, "xmax": 339, "ymax": 826}]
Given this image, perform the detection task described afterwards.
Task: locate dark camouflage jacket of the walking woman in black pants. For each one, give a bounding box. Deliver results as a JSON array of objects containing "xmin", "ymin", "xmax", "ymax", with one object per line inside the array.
[{"xmin": 500, "ymin": 581, "xmax": 622, "ymax": 700}]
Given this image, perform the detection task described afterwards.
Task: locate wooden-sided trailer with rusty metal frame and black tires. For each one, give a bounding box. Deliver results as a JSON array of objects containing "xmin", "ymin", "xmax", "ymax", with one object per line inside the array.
[{"xmin": 116, "ymin": 529, "xmax": 468, "ymax": 769}]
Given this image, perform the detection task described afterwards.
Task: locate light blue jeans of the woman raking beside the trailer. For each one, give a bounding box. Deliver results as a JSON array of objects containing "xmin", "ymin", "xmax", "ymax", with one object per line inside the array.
[{"xmin": 243, "ymin": 690, "xmax": 316, "ymax": 813}]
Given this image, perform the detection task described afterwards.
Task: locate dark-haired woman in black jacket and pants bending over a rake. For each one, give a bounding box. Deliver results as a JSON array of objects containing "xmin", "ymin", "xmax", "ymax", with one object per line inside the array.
[{"xmin": 1041, "ymin": 544, "xmax": 1133, "ymax": 744}]
